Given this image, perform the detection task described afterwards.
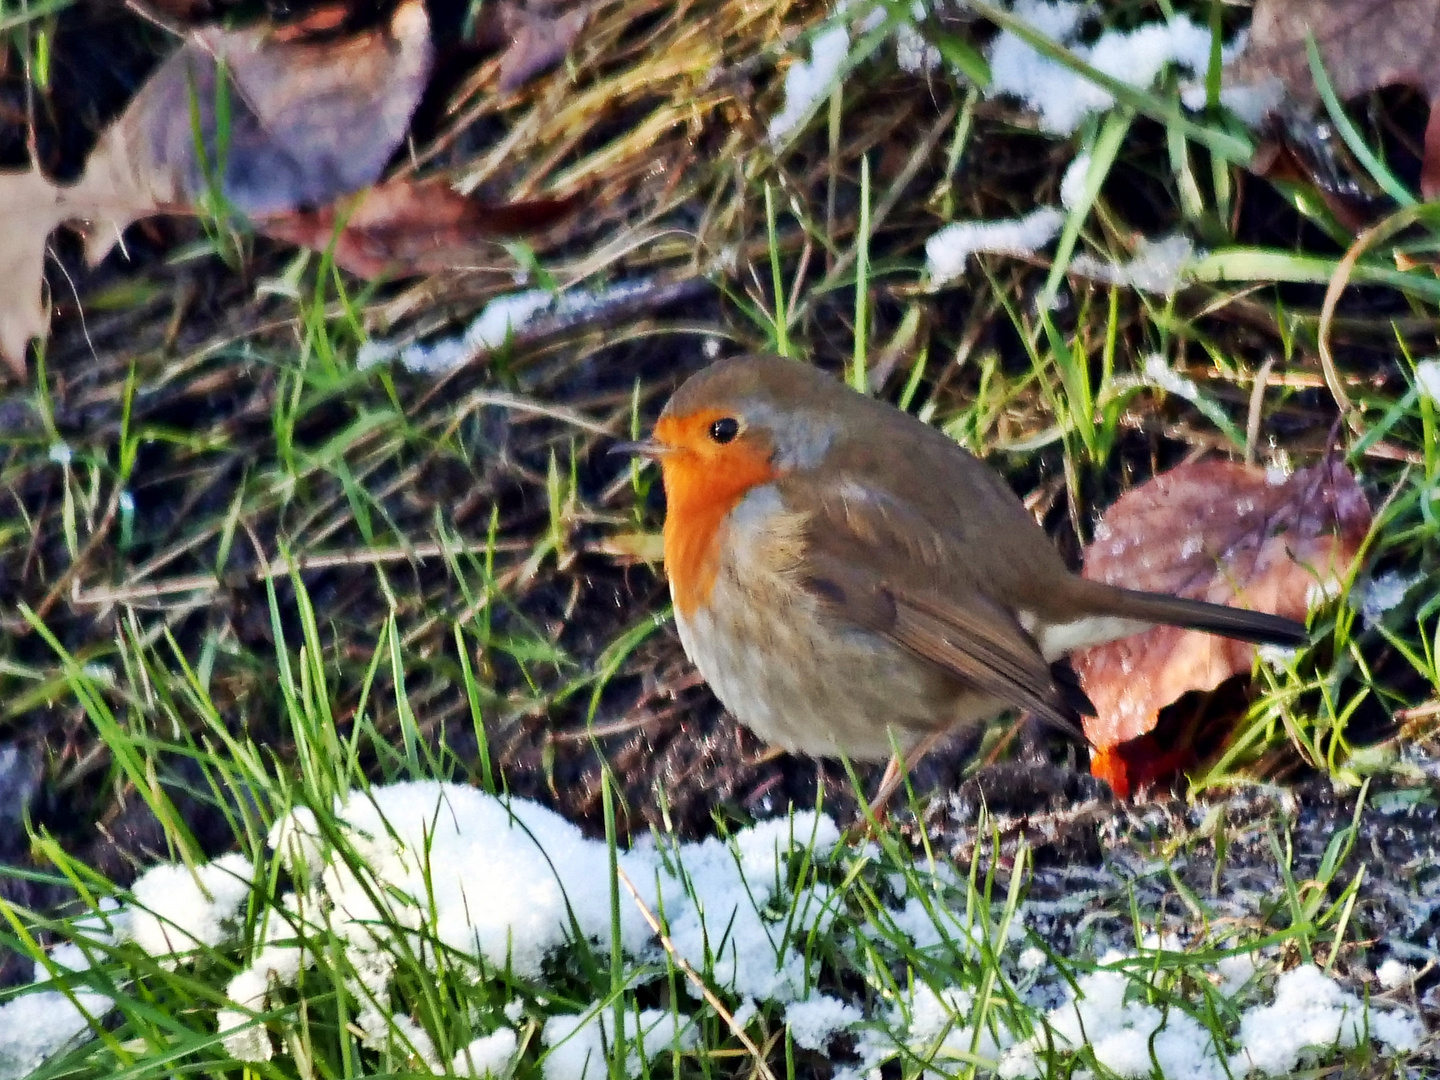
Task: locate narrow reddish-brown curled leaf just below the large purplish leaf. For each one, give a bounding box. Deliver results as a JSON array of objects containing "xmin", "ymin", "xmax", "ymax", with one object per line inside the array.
[{"xmin": 255, "ymin": 177, "xmax": 579, "ymax": 278}]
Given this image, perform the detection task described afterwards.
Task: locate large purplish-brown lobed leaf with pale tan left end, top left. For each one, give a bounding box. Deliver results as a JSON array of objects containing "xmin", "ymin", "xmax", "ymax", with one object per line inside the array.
[{"xmin": 0, "ymin": 0, "xmax": 433, "ymax": 377}]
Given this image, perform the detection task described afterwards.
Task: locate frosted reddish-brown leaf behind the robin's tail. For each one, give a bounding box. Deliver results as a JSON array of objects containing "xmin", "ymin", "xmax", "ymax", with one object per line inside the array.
[{"xmin": 1071, "ymin": 458, "xmax": 1371, "ymax": 794}]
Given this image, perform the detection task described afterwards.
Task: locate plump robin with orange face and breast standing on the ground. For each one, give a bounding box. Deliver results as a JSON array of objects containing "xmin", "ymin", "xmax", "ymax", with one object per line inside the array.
[{"xmin": 616, "ymin": 356, "xmax": 1306, "ymax": 806}]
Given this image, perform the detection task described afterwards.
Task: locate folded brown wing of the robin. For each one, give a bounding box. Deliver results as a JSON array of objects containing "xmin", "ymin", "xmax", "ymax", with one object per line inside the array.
[{"xmin": 782, "ymin": 484, "xmax": 1079, "ymax": 734}]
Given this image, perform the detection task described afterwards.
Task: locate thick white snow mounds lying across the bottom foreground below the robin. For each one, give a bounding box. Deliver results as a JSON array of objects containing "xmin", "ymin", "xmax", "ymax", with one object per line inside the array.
[{"xmin": 11, "ymin": 782, "xmax": 1423, "ymax": 1080}]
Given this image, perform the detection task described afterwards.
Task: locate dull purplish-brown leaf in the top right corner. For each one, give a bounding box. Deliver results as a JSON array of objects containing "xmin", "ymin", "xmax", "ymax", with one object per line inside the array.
[{"xmin": 1227, "ymin": 0, "xmax": 1440, "ymax": 199}]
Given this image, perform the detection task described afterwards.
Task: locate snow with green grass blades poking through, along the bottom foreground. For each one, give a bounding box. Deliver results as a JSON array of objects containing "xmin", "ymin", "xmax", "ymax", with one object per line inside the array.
[{"xmin": 8, "ymin": 783, "xmax": 1421, "ymax": 1080}]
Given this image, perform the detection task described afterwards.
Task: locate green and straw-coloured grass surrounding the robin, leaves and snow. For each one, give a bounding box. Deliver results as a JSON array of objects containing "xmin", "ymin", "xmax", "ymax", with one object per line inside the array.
[{"xmin": 0, "ymin": 0, "xmax": 1440, "ymax": 1080}]
